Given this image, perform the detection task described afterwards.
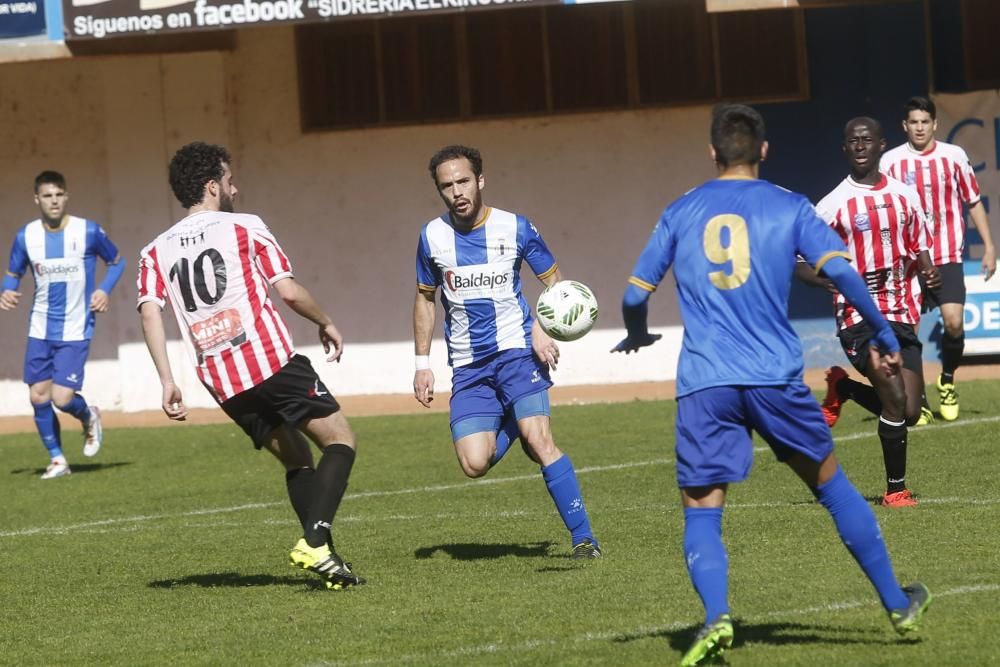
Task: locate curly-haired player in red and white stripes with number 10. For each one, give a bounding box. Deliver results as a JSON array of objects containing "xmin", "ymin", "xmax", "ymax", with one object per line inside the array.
[{"xmin": 137, "ymin": 142, "xmax": 364, "ymax": 590}]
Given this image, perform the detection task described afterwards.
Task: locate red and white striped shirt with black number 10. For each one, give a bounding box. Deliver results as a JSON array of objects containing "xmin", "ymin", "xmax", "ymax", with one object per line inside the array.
[{"xmin": 137, "ymin": 211, "xmax": 295, "ymax": 403}]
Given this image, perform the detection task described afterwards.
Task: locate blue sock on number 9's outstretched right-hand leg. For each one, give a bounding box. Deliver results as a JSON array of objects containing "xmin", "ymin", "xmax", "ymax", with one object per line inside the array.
[{"xmin": 815, "ymin": 467, "xmax": 909, "ymax": 610}]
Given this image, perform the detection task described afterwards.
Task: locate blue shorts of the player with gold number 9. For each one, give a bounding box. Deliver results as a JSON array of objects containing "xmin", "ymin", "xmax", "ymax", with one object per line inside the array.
[{"xmin": 677, "ymin": 382, "xmax": 833, "ymax": 489}]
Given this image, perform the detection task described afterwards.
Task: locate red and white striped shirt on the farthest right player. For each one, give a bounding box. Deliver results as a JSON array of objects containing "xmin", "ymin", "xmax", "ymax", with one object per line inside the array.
[{"xmin": 880, "ymin": 141, "xmax": 980, "ymax": 265}]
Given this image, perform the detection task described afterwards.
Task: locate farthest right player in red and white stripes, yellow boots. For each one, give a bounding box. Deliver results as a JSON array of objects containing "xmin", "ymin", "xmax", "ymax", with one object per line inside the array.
[{"xmin": 882, "ymin": 97, "xmax": 997, "ymax": 423}]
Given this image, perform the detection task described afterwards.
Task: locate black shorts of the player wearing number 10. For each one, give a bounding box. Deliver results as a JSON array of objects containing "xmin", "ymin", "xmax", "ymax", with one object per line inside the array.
[{"xmin": 222, "ymin": 354, "xmax": 340, "ymax": 449}]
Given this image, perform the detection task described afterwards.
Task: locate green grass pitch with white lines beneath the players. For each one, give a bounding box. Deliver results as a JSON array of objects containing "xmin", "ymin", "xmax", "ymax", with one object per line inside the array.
[{"xmin": 0, "ymin": 381, "xmax": 1000, "ymax": 666}]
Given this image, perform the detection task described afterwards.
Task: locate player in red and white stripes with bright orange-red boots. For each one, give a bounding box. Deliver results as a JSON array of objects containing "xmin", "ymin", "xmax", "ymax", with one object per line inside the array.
[{"xmin": 816, "ymin": 117, "xmax": 939, "ymax": 507}]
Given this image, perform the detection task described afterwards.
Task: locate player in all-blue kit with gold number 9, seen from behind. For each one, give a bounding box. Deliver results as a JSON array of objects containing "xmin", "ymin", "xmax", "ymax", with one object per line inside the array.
[{"xmin": 613, "ymin": 105, "xmax": 931, "ymax": 665}]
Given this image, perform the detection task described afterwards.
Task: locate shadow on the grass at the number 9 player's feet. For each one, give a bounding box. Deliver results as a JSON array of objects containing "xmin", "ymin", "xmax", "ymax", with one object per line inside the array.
[{"xmin": 613, "ymin": 620, "xmax": 920, "ymax": 652}]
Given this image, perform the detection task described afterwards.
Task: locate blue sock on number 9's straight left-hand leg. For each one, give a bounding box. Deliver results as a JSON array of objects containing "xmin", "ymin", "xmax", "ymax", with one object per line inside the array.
[{"xmin": 684, "ymin": 507, "xmax": 729, "ymax": 623}]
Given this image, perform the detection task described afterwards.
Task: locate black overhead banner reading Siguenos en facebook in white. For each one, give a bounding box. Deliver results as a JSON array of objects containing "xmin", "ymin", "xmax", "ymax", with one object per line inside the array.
[{"xmin": 62, "ymin": 0, "xmax": 564, "ymax": 40}]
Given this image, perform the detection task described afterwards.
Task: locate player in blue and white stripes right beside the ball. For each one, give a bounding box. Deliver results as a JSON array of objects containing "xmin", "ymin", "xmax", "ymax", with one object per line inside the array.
[{"xmin": 413, "ymin": 146, "xmax": 601, "ymax": 559}]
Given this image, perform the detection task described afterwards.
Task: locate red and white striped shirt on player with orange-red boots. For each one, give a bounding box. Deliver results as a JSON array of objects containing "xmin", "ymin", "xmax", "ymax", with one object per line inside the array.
[{"xmin": 816, "ymin": 175, "xmax": 931, "ymax": 329}]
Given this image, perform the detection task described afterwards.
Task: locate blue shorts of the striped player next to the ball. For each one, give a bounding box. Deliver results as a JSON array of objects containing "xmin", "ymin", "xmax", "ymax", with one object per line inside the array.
[{"xmin": 451, "ymin": 349, "xmax": 552, "ymax": 440}]
